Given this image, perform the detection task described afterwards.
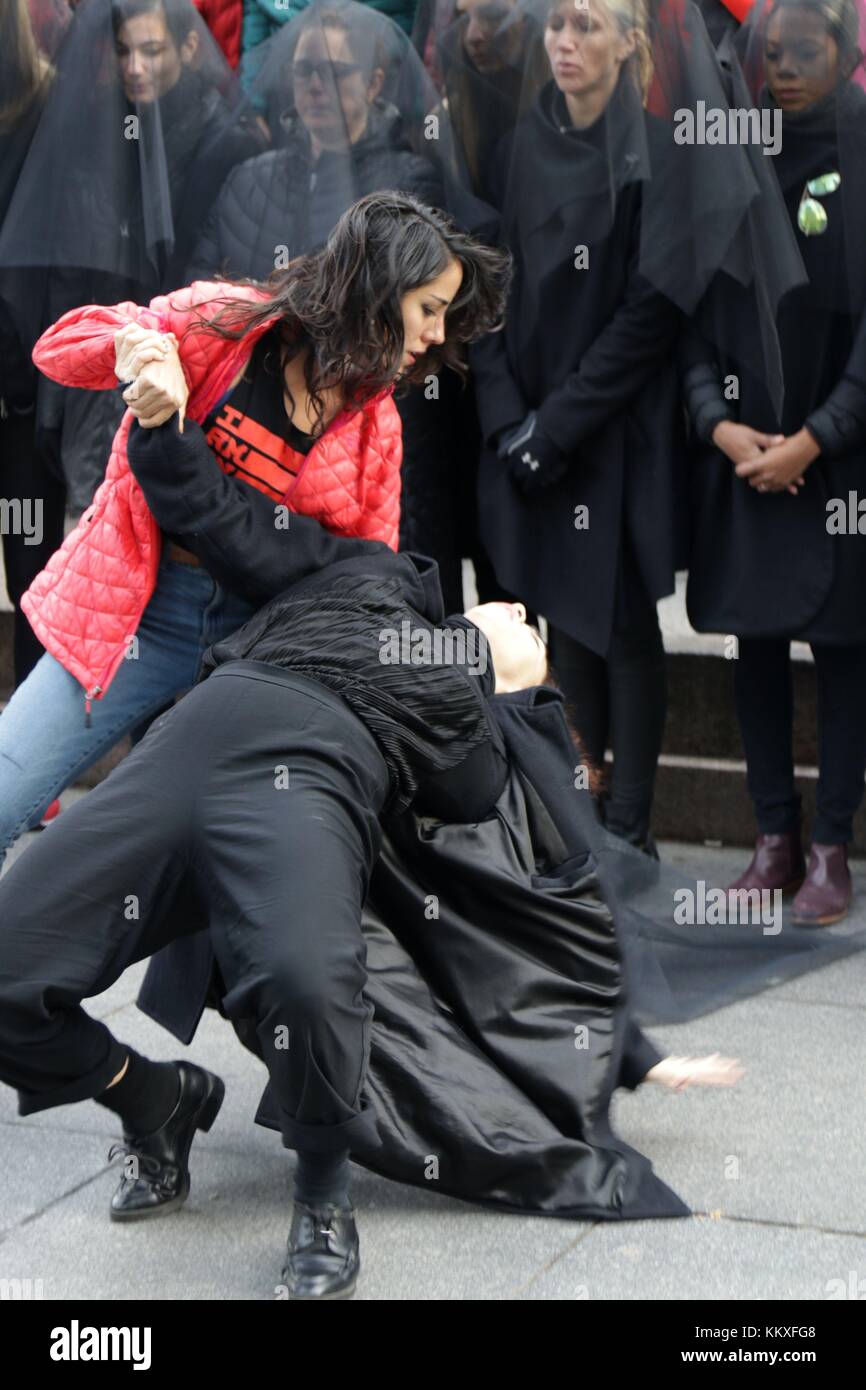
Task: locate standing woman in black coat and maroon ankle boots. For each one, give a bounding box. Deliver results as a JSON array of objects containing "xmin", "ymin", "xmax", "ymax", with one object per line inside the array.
[{"xmin": 685, "ymin": 0, "xmax": 866, "ymax": 924}]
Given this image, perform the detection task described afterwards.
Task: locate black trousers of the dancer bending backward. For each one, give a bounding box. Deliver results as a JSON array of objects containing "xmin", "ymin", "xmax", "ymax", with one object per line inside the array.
[{"xmin": 0, "ymin": 662, "xmax": 389, "ymax": 1152}]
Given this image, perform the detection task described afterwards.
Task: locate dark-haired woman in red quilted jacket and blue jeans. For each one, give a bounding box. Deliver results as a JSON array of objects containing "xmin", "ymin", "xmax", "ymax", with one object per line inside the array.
[{"xmin": 0, "ymin": 193, "xmax": 507, "ymax": 859}]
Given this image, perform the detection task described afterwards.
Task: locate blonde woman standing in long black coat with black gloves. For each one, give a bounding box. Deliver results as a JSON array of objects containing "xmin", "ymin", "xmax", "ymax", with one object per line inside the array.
[{"xmin": 473, "ymin": 0, "xmax": 678, "ymax": 847}]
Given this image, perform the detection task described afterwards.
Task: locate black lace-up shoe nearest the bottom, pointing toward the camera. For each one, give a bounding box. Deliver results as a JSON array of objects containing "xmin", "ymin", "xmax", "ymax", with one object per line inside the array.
[{"xmin": 282, "ymin": 1202, "xmax": 361, "ymax": 1298}]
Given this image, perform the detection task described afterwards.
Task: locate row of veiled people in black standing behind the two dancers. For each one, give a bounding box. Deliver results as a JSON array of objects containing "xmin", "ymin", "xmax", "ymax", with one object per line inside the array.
[{"xmin": 0, "ymin": 0, "xmax": 866, "ymax": 920}]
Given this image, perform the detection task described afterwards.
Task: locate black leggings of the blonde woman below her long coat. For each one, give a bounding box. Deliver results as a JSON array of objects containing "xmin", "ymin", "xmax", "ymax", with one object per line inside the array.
[{"xmin": 549, "ymin": 575, "xmax": 667, "ymax": 847}]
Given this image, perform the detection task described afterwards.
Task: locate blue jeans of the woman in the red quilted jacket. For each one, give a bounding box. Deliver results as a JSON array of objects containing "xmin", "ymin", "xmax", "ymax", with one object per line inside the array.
[{"xmin": 0, "ymin": 556, "xmax": 256, "ymax": 866}]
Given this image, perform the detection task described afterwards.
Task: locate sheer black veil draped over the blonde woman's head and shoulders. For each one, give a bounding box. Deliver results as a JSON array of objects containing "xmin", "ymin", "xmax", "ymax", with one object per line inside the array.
[{"xmin": 464, "ymin": 0, "xmax": 805, "ymax": 411}]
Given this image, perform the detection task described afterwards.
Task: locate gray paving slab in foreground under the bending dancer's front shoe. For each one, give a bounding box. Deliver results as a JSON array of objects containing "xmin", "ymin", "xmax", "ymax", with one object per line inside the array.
[{"xmin": 0, "ymin": 1136, "xmax": 586, "ymax": 1300}]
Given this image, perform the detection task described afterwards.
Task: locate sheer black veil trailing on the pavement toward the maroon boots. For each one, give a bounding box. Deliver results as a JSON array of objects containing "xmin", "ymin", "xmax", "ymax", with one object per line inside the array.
[{"xmin": 480, "ymin": 687, "xmax": 866, "ymax": 1024}]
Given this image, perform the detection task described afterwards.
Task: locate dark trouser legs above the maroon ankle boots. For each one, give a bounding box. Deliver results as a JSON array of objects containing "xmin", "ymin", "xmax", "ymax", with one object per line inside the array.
[{"xmin": 734, "ymin": 637, "xmax": 866, "ymax": 845}]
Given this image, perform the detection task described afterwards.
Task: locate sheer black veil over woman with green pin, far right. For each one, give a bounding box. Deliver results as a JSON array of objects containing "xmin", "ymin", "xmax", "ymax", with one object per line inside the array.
[{"xmin": 683, "ymin": 0, "xmax": 866, "ymax": 432}]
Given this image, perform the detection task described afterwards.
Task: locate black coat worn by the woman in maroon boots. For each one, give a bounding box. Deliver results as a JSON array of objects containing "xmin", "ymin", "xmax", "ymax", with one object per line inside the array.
[{"xmin": 684, "ymin": 83, "xmax": 866, "ymax": 644}]
